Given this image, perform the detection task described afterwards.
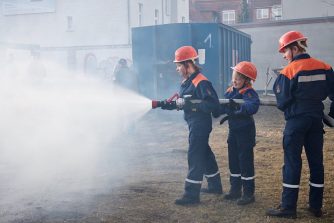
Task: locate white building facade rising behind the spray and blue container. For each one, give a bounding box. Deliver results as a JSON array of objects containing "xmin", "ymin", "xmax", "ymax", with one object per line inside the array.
[{"xmin": 0, "ymin": 0, "xmax": 189, "ymax": 75}]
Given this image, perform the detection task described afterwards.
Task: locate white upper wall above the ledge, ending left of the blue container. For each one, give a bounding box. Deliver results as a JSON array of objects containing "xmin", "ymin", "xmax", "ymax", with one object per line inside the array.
[{"xmin": 0, "ymin": 0, "xmax": 129, "ymax": 46}]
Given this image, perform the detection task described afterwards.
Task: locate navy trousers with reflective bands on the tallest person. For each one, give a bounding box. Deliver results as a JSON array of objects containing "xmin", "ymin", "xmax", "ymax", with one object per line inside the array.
[{"xmin": 281, "ymin": 116, "xmax": 324, "ymax": 209}]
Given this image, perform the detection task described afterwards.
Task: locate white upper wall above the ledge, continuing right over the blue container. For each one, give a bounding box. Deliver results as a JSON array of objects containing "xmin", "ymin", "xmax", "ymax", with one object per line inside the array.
[{"xmin": 0, "ymin": 0, "xmax": 189, "ymax": 46}]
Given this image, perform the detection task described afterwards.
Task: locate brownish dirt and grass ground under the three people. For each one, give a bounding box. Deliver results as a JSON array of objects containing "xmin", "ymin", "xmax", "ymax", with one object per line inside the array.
[{"xmin": 0, "ymin": 103, "xmax": 334, "ymax": 223}]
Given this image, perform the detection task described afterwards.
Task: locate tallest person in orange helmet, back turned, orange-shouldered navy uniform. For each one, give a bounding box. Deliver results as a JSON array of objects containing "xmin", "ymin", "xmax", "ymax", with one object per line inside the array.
[{"xmin": 266, "ymin": 31, "xmax": 334, "ymax": 218}]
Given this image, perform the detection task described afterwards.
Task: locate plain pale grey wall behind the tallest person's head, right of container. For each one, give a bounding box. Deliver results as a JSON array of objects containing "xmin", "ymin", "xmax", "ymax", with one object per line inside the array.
[{"xmin": 239, "ymin": 22, "xmax": 334, "ymax": 90}]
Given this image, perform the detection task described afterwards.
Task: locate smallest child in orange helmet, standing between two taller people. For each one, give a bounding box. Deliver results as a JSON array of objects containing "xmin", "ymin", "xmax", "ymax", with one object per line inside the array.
[{"xmin": 221, "ymin": 61, "xmax": 260, "ymax": 205}]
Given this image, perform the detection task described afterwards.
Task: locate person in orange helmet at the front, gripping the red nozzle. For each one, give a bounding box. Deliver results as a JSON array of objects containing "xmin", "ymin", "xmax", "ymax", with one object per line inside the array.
[{"xmin": 161, "ymin": 46, "xmax": 223, "ymax": 205}]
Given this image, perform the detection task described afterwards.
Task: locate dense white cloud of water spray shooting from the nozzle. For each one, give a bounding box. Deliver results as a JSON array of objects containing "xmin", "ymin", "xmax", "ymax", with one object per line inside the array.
[{"xmin": 0, "ymin": 59, "xmax": 150, "ymax": 209}]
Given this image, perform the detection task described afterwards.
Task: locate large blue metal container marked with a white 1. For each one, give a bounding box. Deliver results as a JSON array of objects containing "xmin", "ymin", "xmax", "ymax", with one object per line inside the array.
[{"xmin": 132, "ymin": 23, "xmax": 251, "ymax": 99}]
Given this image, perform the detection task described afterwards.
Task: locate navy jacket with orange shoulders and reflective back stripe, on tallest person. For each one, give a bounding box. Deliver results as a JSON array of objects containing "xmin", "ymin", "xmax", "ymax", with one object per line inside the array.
[{"xmin": 273, "ymin": 53, "xmax": 334, "ymax": 120}]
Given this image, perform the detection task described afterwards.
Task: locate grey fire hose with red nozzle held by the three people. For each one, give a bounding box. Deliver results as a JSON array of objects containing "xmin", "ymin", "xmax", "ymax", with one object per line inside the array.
[{"xmin": 152, "ymin": 93, "xmax": 334, "ymax": 128}]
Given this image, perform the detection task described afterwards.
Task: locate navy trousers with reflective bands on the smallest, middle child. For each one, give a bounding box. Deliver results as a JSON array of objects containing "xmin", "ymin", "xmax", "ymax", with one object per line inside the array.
[{"xmin": 227, "ymin": 123, "xmax": 256, "ymax": 196}]
